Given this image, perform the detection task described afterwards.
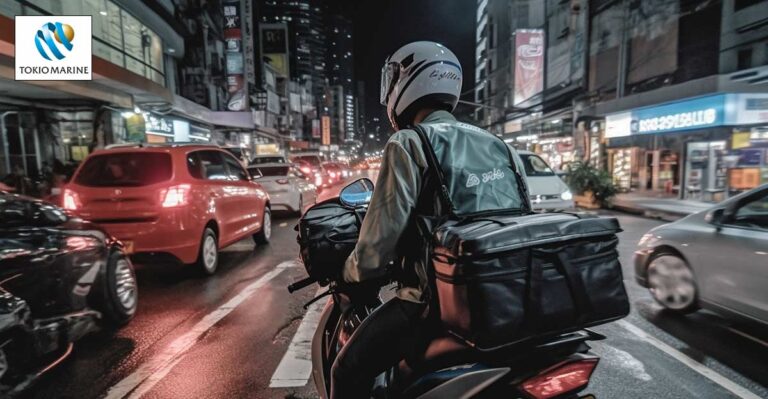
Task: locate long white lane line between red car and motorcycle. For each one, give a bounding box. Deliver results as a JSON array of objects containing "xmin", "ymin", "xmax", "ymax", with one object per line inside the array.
[{"xmin": 106, "ymin": 260, "xmax": 296, "ymax": 399}]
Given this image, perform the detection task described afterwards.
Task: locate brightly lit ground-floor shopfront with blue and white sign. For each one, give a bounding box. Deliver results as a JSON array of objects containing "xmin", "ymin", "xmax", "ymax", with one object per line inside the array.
[{"xmin": 605, "ymin": 93, "xmax": 768, "ymax": 202}]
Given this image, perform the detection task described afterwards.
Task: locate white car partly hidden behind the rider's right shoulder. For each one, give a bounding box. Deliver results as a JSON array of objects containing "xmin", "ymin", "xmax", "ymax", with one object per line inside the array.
[{"xmin": 513, "ymin": 150, "xmax": 575, "ymax": 210}]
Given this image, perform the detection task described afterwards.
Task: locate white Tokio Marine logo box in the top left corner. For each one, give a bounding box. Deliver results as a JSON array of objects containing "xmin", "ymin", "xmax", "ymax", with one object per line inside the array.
[{"xmin": 14, "ymin": 15, "xmax": 93, "ymax": 80}]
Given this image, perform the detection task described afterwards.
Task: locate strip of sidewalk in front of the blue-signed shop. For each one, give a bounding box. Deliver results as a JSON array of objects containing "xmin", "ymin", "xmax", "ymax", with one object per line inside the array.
[{"xmin": 611, "ymin": 192, "xmax": 714, "ymax": 221}]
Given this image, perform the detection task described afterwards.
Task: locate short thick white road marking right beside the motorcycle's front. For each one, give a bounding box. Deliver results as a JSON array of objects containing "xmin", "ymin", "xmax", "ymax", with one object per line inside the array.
[{"xmin": 269, "ymin": 288, "xmax": 326, "ymax": 388}]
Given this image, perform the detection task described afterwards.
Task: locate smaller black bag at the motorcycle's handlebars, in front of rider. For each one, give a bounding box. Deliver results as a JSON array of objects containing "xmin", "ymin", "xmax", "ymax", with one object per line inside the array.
[{"xmin": 297, "ymin": 200, "xmax": 365, "ymax": 285}]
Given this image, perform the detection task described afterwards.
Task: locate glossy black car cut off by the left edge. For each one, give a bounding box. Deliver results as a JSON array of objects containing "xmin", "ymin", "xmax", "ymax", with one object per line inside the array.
[{"xmin": 0, "ymin": 192, "xmax": 138, "ymax": 397}]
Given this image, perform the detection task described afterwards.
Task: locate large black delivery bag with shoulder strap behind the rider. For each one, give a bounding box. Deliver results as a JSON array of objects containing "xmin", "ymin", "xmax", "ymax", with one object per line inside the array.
[{"xmin": 416, "ymin": 127, "xmax": 629, "ymax": 351}]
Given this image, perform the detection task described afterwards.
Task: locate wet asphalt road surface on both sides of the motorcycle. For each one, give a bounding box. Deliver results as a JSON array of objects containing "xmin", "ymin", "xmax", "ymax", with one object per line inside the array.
[{"xmin": 18, "ymin": 183, "xmax": 768, "ymax": 399}]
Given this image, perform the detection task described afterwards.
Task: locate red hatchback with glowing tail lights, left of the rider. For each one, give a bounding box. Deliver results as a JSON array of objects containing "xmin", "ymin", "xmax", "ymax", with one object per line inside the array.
[{"xmin": 62, "ymin": 145, "xmax": 272, "ymax": 274}]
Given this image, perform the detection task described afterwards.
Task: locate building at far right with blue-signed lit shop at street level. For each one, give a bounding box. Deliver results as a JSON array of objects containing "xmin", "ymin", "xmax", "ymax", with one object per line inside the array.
[{"xmin": 581, "ymin": 1, "xmax": 768, "ymax": 201}]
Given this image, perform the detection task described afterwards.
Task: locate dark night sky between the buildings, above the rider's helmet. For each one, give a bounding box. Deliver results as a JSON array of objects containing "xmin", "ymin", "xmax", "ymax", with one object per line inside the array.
[{"xmin": 339, "ymin": 0, "xmax": 477, "ymax": 131}]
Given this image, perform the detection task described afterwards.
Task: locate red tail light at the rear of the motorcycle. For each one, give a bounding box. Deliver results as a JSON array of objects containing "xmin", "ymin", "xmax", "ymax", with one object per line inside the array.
[{"xmin": 518, "ymin": 358, "xmax": 598, "ymax": 399}]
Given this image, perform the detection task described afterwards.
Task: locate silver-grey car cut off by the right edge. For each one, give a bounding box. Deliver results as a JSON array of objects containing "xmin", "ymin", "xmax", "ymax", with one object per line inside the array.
[{"xmin": 635, "ymin": 184, "xmax": 768, "ymax": 324}]
